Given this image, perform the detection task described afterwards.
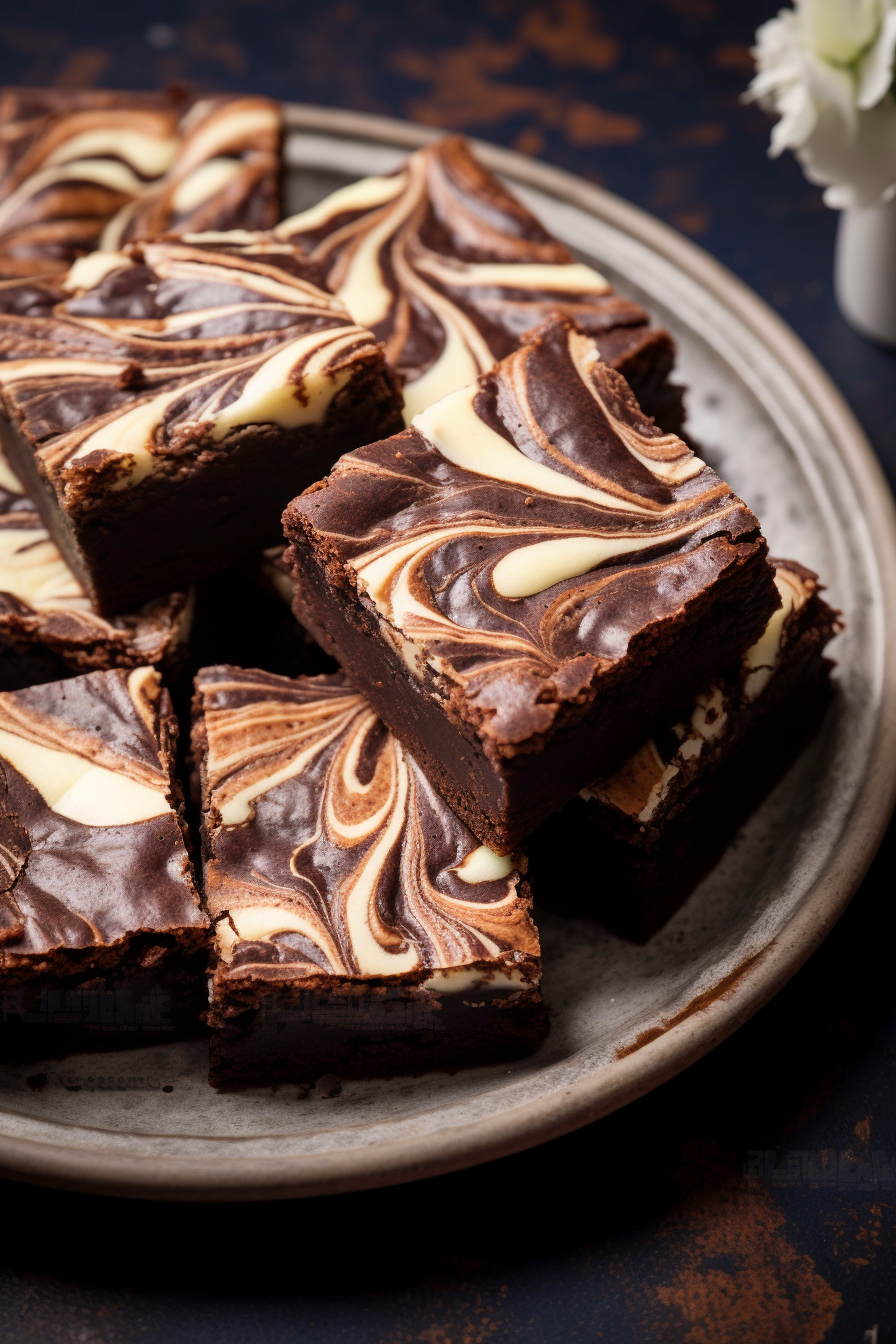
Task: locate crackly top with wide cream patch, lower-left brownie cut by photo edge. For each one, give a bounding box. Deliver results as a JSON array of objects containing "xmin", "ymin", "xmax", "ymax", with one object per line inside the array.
[{"xmin": 0, "ymin": 668, "xmax": 204, "ymax": 966}]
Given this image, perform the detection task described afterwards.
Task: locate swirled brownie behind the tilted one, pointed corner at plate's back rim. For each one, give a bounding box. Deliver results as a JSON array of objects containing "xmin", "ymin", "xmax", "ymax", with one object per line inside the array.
[{"xmin": 278, "ymin": 136, "xmax": 684, "ymax": 431}]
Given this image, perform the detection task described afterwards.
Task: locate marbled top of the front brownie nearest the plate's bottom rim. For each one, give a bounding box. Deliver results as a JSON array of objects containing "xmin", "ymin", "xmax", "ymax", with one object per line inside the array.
[{"xmin": 193, "ymin": 667, "xmax": 539, "ymax": 984}]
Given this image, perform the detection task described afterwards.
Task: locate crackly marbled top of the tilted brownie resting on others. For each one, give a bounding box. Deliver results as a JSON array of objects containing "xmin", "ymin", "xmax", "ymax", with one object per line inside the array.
[{"xmin": 285, "ymin": 319, "xmax": 774, "ymax": 743}]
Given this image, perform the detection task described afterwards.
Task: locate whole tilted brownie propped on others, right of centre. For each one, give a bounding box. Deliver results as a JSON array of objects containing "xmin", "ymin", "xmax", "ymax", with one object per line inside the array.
[{"xmin": 283, "ymin": 317, "xmax": 779, "ymax": 853}]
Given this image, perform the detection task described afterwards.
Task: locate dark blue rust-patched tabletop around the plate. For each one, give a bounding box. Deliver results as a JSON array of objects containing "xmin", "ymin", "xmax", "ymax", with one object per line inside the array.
[{"xmin": 0, "ymin": 0, "xmax": 896, "ymax": 1344}]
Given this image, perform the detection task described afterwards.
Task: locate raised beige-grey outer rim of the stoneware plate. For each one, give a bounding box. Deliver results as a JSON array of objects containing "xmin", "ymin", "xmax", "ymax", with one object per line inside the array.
[{"xmin": 0, "ymin": 103, "xmax": 896, "ymax": 1200}]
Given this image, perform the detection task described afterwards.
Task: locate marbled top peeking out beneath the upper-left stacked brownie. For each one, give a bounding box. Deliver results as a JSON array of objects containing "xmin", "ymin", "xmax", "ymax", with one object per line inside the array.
[{"xmin": 0, "ymin": 453, "xmax": 192, "ymax": 667}]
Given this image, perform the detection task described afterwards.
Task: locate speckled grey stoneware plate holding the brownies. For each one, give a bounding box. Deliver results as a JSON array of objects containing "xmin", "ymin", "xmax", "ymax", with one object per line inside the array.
[{"xmin": 0, "ymin": 106, "xmax": 896, "ymax": 1199}]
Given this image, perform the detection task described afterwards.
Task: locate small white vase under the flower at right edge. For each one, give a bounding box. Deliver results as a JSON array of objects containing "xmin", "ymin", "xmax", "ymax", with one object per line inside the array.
[{"xmin": 834, "ymin": 200, "xmax": 896, "ymax": 345}]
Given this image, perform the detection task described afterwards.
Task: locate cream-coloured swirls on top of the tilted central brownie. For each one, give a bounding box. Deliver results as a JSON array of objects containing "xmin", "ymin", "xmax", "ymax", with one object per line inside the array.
[{"xmin": 343, "ymin": 324, "xmax": 743, "ymax": 693}]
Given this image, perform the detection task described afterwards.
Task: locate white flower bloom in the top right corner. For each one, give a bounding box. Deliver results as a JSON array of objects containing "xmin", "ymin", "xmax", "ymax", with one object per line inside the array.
[{"xmin": 746, "ymin": 0, "xmax": 896, "ymax": 210}]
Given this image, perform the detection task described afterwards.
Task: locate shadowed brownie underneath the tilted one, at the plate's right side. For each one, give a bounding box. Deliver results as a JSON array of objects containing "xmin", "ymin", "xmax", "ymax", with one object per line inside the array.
[{"xmin": 529, "ymin": 560, "xmax": 841, "ymax": 941}]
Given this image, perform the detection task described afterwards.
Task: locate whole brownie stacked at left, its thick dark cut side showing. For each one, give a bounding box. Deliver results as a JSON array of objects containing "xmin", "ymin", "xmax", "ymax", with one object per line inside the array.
[{"xmin": 0, "ymin": 231, "xmax": 402, "ymax": 616}]
